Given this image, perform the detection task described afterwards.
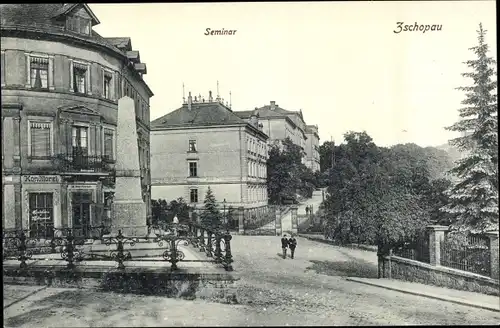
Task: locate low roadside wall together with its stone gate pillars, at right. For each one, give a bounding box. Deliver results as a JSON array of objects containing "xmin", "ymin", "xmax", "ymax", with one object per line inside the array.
[{"xmin": 378, "ymin": 226, "xmax": 500, "ymax": 295}]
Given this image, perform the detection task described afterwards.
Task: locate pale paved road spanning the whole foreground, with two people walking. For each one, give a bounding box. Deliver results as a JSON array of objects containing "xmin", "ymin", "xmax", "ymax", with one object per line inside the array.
[{"xmin": 4, "ymin": 236, "xmax": 500, "ymax": 327}]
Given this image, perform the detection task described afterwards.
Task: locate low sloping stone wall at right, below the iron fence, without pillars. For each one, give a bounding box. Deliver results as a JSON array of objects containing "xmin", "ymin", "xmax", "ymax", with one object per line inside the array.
[{"xmin": 379, "ymin": 256, "xmax": 500, "ymax": 295}]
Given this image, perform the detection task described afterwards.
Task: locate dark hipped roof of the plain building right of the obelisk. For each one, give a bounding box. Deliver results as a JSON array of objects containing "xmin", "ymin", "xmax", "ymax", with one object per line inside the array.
[{"xmin": 151, "ymin": 102, "xmax": 247, "ymax": 130}]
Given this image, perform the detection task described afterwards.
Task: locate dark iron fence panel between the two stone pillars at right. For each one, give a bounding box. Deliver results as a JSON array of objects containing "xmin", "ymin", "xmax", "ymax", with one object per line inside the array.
[{"xmin": 440, "ymin": 235, "xmax": 491, "ymax": 277}]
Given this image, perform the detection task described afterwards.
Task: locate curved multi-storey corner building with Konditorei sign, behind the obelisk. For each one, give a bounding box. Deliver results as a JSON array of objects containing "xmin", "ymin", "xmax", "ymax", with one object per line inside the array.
[{"xmin": 0, "ymin": 4, "xmax": 153, "ymax": 237}]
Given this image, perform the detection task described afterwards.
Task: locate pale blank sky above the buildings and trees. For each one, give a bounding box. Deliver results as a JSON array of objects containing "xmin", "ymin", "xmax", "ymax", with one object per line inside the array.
[{"xmin": 89, "ymin": 1, "xmax": 496, "ymax": 147}]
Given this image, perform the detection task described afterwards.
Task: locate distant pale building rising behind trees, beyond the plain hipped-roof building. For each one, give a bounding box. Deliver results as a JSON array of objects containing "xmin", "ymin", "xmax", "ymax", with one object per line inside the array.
[{"xmin": 235, "ymin": 101, "xmax": 319, "ymax": 171}]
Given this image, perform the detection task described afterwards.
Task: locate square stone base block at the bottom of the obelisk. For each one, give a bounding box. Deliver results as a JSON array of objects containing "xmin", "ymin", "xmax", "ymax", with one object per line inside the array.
[{"xmin": 111, "ymin": 200, "xmax": 148, "ymax": 237}]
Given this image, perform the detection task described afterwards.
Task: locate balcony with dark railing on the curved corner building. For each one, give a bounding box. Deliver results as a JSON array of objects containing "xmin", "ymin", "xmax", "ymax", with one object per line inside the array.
[{"xmin": 53, "ymin": 154, "xmax": 113, "ymax": 175}]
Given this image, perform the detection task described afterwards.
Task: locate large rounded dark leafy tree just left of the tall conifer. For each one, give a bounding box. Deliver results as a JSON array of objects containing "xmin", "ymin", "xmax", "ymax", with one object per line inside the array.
[{"xmin": 322, "ymin": 132, "xmax": 447, "ymax": 244}]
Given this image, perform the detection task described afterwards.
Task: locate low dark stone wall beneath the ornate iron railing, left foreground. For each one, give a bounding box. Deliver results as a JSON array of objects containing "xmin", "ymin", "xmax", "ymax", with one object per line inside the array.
[{"xmin": 4, "ymin": 266, "xmax": 237, "ymax": 303}]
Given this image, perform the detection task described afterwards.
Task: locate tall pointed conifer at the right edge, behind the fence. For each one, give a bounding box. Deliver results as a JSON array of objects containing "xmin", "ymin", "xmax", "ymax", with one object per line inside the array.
[{"xmin": 442, "ymin": 24, "xmax": 498, "ymax": 232}]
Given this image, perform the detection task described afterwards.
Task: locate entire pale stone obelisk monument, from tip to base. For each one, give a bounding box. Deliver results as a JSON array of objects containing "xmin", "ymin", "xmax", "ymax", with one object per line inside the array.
[{"xmin": 111, "ymin": 96, "xmax": 148, "ymax": 237}]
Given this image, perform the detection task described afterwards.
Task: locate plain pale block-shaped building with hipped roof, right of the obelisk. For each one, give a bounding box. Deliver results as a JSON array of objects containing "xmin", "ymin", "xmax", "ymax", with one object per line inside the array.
[{"xmin": 151, "ymin": 93, "xmax": 268, "ymax": 217}]
